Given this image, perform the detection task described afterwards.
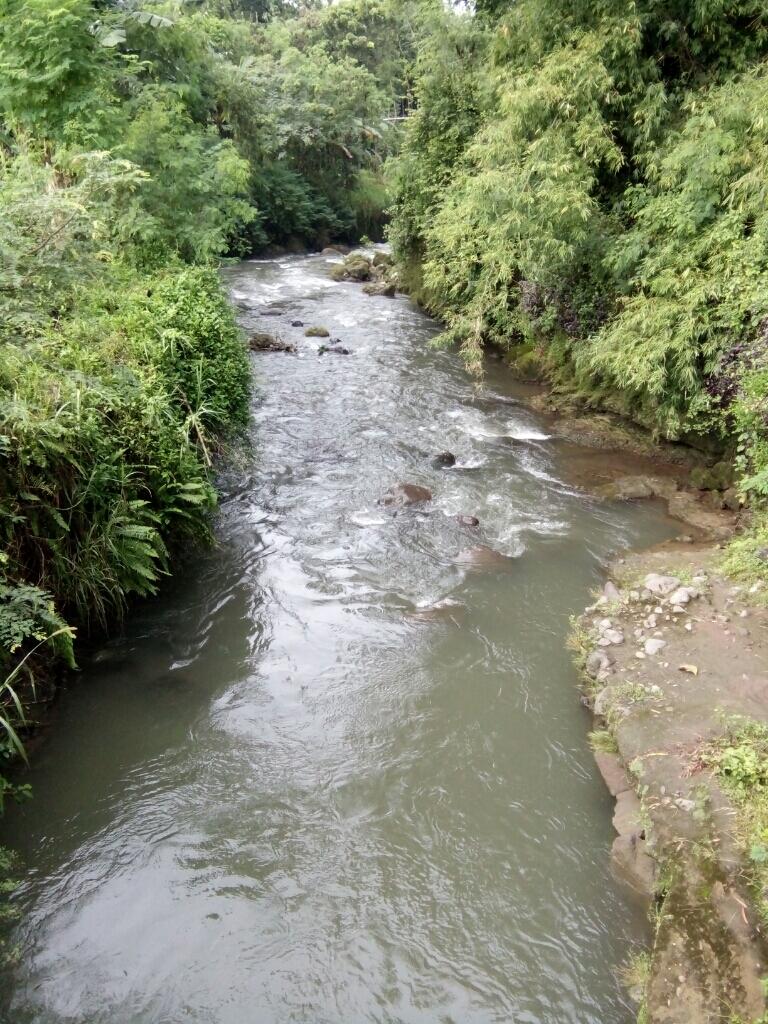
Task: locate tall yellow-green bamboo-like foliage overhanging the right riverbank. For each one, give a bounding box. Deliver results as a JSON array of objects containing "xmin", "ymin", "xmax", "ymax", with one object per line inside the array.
[{"xmin": 391, "ymin": 0, "xmax": 768, "ymax": 499}]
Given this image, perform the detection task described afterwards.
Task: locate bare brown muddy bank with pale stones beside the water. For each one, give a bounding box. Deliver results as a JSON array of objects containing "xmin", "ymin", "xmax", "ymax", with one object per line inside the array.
[{"xmin": 572, "ymin": 544, "xmax": 768, "ymax": 1024}]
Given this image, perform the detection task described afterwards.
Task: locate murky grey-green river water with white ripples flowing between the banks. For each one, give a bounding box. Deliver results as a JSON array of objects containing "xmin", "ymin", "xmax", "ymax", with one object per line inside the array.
[{"xmin": 0, "ymin": 249, "xmax": 674, "ymax": 1024}]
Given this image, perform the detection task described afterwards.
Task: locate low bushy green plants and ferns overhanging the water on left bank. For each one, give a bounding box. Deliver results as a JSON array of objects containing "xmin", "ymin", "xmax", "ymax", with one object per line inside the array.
[{"xmin": 0, "ymin": 260, "xmax": 248, "ymax": 621}]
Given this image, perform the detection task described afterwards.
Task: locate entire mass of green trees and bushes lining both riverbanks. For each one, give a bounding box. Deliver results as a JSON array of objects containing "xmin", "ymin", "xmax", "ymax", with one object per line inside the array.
[{"xmin": 6, "ymin": 0, "xmax": 768, "ymax": 790}]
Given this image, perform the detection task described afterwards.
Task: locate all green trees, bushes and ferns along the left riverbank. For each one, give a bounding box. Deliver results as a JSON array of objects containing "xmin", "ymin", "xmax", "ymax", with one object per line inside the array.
[{"xmin": 0, "ymin": 0, "xmax": 409, "ymax": 800}]
